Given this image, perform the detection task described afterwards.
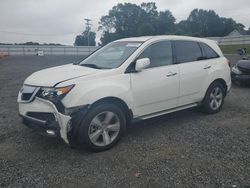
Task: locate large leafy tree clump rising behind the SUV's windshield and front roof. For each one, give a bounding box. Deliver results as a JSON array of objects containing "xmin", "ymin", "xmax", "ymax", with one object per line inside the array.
[{"xmin": 99, "ymin": 2, "xmax": 175, "ymax": 45}]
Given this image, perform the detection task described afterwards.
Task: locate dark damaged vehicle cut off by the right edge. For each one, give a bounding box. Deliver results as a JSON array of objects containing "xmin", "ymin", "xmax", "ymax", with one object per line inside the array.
[{"xmin": 231, "ymin": 48, "xmax": 250, "ymax": 85}]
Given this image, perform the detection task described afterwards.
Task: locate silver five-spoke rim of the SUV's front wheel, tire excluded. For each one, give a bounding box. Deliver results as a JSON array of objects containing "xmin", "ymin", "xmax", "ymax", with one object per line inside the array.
[{"xmin": 88, "ymin": 111, "xmax": 120, "ymax": 146}]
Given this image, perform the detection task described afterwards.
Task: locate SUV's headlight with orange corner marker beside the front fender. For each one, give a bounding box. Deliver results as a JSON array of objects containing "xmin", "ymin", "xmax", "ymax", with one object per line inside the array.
[{"xmin": 40, "ymin": 85, "xmax": 75, "ymax": 101}]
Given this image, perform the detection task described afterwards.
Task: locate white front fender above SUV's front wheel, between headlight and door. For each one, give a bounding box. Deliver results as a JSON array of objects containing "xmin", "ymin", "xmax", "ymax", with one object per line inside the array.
[{"xmin": 62, "ymin": 74, "xmax": 133, "ymax": 109}]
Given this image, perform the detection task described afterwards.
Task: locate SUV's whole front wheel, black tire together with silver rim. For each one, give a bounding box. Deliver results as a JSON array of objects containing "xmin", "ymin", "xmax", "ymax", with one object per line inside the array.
[{"xmin": 77, "ymin": 103, "xmax": 126, "ymax": 152}]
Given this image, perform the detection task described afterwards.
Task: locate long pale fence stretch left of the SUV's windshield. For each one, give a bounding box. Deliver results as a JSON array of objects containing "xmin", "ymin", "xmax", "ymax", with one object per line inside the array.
[{"xmin": 0, "ymin": 45, "xmax": 98, "ymax": 55}]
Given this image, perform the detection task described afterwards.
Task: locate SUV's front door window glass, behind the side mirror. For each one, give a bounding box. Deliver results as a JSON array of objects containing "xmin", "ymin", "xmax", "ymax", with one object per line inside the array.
[{"xmin": 138, "ymin": 41, "xmax": 173, "ymax": 67}]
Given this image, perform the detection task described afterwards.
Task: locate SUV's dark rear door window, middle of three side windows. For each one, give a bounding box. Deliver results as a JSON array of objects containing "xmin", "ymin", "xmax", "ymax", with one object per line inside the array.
[{"xmin": 174, "ymin": 41, "xmax": 202, "ymax": 63}]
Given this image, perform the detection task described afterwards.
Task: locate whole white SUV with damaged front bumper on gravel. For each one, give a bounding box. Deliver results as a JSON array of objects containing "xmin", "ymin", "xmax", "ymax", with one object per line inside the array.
[{"xmin": 18, "ymin": 36, "xmax": 231, "ymax": 151}]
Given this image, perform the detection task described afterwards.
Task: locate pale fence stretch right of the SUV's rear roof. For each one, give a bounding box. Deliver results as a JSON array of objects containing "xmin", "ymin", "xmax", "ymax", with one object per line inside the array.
[{"xmin": 209, "ymin": 35, "xmax": 250, "ymax": 45}]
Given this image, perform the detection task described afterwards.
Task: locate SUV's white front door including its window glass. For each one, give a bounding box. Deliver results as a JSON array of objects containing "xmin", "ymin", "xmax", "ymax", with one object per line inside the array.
[{"xmin": 131, "ymin": 41, "xmax": 179, "ymax": 117}]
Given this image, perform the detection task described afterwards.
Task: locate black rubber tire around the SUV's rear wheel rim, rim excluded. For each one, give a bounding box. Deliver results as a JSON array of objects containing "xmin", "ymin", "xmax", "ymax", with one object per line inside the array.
[{"xmin": 201, "ymin": 82, "xmax": 226, "ymax": 114}]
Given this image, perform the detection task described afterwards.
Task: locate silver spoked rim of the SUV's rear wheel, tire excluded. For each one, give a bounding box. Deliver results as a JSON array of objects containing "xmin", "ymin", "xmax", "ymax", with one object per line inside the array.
[{"xmin": 210, "ymin": 87, "xmax": 223, "ymax": 110}]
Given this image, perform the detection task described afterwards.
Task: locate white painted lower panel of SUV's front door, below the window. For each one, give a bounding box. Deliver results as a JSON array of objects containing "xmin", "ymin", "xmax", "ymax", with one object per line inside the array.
[{"xmin": 131, "ymin": 65, "xmax": 179, "ymax": 116}]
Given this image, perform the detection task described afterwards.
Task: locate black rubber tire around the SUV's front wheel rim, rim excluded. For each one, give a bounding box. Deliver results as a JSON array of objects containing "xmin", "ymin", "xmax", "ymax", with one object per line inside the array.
[{"xmin": 77, "ymin": 103, "xmax": 126, "ymax": 152}]
